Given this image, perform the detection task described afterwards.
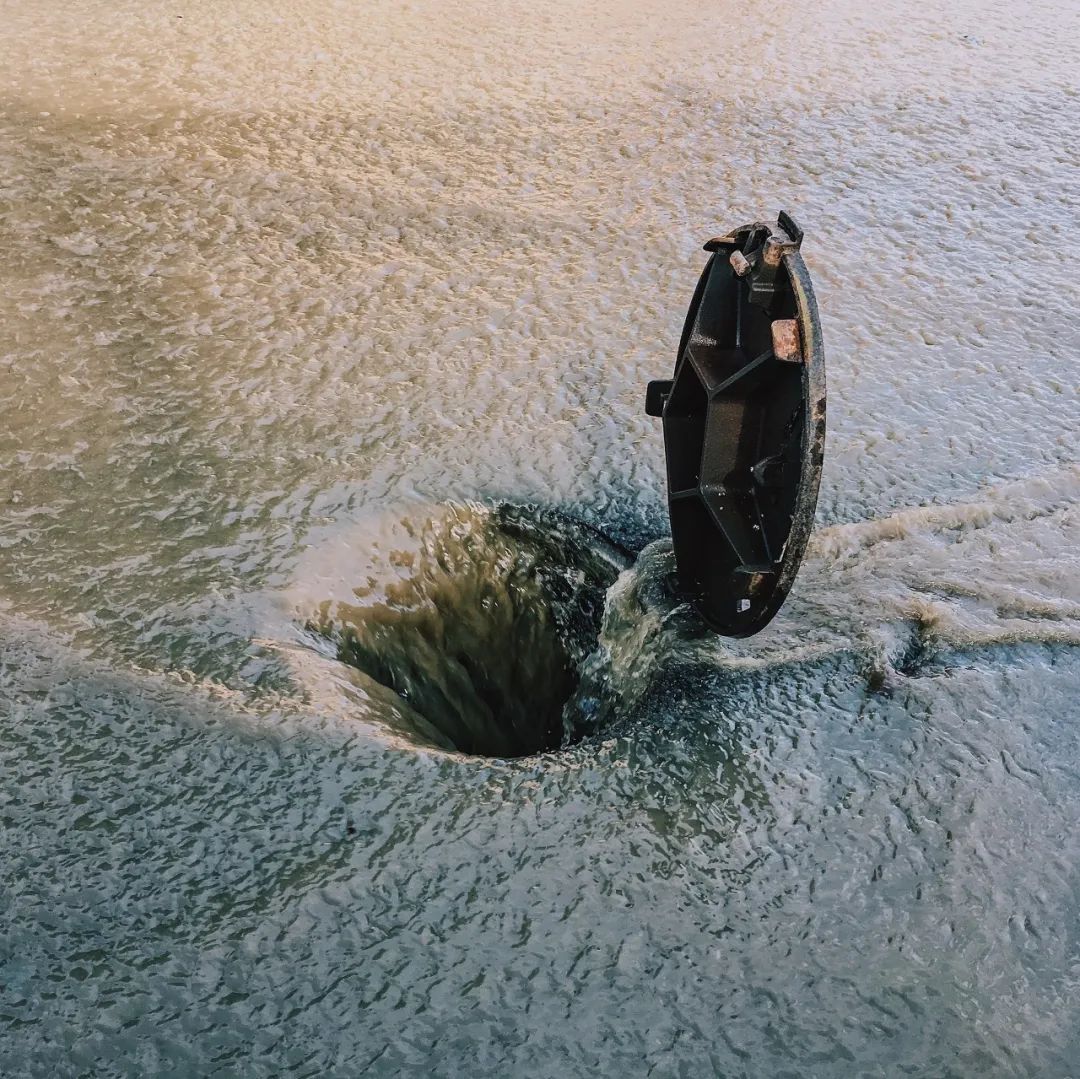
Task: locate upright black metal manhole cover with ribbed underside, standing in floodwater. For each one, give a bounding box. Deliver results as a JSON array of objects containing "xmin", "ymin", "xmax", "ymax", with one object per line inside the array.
[{"xmin": 646, "ymin": 213, "xmax": 825, "ymax": 637}]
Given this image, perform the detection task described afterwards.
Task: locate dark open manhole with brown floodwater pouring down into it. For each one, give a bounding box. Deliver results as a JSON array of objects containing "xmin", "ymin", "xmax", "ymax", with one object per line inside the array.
[{"xmin": 314, "ymin": 505, "xmax": 629, "ymax": 757}]
